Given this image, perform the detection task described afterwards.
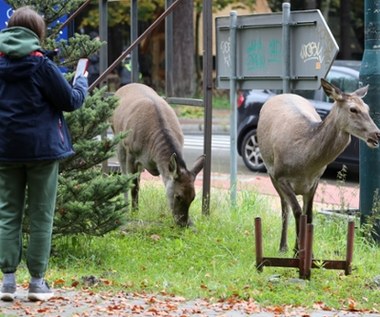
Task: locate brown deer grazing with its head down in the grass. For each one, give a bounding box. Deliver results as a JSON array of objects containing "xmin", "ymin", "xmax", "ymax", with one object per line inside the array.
[{"xmin": 112, "ymin": 83, "xmax": 205, "ymax": 226}]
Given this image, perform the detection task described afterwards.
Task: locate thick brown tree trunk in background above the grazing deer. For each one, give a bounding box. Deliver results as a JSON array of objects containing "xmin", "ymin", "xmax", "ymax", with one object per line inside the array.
[{"xmin": 173, "ymin": 0, "xmax": 195, "ymax": 97}]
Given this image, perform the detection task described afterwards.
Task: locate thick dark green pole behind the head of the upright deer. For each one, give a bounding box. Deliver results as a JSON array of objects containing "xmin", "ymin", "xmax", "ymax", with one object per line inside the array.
[{"xmin": 359, "ymin": 0, "xmax": 380, "ymax": 242}]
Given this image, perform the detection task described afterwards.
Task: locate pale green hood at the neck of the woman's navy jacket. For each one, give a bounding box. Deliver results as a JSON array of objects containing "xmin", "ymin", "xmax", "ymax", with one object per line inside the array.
[{"xmin": 0, "ymin": 26, "xmax": 41, "ymax": 58}]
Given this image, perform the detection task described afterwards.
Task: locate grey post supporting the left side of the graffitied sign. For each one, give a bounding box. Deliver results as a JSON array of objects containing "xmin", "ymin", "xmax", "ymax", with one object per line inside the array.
[{"xmin": 230, "ymin": 11, "xmax": 237, "ymax": 207}]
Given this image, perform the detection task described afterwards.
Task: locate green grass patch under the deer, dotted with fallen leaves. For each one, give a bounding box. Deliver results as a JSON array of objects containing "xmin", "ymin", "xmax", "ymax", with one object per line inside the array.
[{"xmin": 15, "ymin": 182, "xmax": 380, "ymax": 311}]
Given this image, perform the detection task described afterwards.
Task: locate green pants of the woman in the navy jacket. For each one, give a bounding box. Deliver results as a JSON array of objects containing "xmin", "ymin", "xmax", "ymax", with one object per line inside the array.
[{"xmin": 0, "ymin": 161, "xmax": 59, "ymax": 277}]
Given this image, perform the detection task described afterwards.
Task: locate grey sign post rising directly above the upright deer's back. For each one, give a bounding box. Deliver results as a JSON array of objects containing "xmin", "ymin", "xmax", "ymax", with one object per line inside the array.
[{"xmin": 282, "ymin": 2, "xmax": 290, "ymax": 93}]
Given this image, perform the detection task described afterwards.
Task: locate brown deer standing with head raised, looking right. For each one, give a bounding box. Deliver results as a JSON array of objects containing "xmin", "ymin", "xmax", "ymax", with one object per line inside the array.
[{"xmin": 257, "ymin": 79, "xmax": 380, "ymax": 252}]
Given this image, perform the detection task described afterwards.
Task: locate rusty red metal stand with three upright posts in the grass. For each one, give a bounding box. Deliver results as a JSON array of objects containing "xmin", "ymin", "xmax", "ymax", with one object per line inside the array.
[{"xmin": 255, "ymin": 215, "xmax": 355, "ymax": 279}]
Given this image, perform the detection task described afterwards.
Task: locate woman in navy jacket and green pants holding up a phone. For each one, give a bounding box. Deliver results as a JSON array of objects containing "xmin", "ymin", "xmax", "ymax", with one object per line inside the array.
[{"xmin": 0, "ymin": 6, "xmax": 88, "ymax": 301}]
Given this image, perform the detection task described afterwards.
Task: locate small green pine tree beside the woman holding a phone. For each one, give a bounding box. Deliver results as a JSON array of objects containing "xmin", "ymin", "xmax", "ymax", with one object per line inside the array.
[{"xmin": 8, "ymin": 0, "xmax": 134, "ymax": 235}]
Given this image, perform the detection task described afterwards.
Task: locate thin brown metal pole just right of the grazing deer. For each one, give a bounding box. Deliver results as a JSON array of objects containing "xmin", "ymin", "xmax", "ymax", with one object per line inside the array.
[{"xmin": 202, "ymin": 0, "xmax": 213, "ymax": 215}]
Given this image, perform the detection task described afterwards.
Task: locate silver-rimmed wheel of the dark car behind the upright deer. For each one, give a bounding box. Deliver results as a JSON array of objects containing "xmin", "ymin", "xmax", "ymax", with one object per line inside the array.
[{"xmin": 241, "ymin": 129, "xmax": 266, "ymax": 172}]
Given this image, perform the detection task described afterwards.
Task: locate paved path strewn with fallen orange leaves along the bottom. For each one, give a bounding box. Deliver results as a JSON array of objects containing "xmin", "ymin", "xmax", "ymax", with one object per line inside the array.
[{"xmin": 0, "ymin": 289, "xmax": 380, "ymax": 317}]
